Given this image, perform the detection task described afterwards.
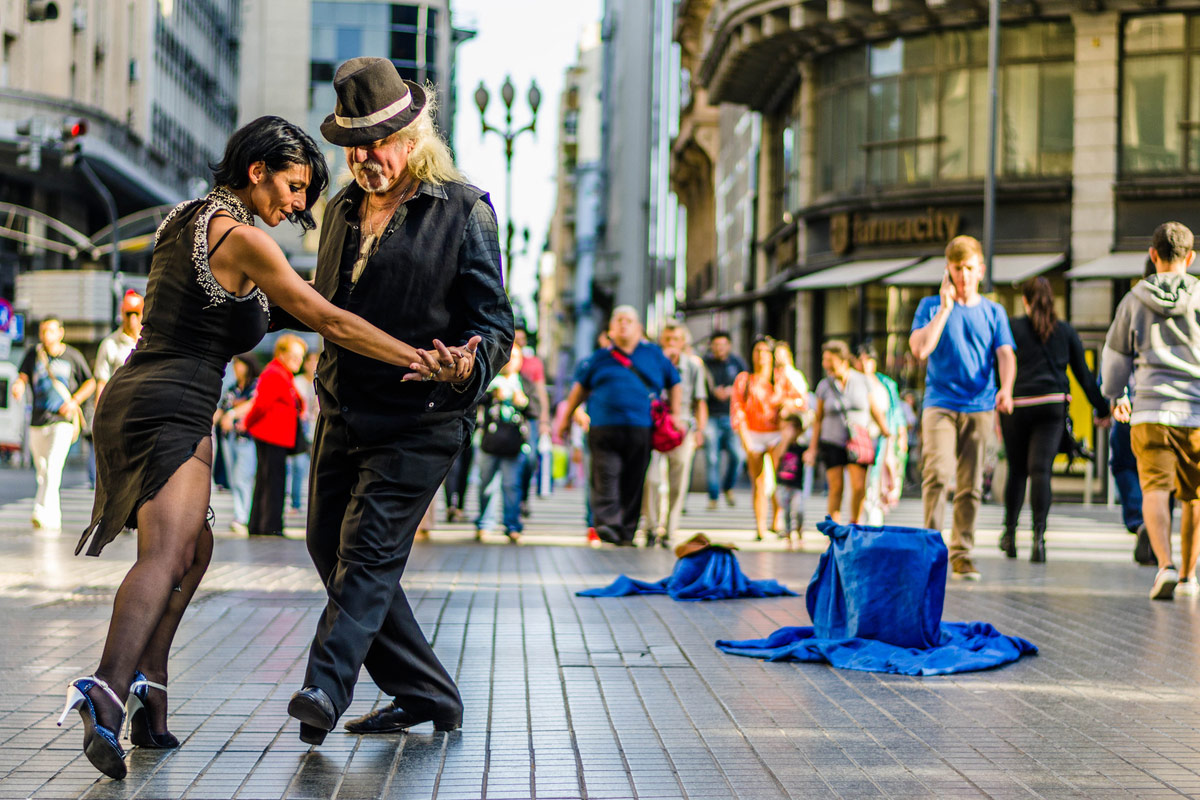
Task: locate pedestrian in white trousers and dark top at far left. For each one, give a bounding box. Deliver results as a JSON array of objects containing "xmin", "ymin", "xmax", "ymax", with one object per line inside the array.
[{"xmin": 11, "ymin": 317, "xmax": 96, "ymax": 535}]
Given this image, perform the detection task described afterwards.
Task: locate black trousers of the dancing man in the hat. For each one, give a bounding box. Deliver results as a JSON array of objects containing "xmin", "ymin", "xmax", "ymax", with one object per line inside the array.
[{"xmin": 305, "ymin": 415, "xmax": 465, "ymax": 721}]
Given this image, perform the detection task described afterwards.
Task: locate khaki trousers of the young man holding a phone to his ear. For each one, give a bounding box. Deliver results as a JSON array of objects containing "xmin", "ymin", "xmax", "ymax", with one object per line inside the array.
[{"xmin": 920, "ymin": 408, "xmax": 996, "ymax": 561}]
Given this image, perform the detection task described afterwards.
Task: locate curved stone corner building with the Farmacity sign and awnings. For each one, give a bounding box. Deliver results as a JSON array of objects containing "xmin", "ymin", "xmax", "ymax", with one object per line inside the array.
[{"xmin": 677, "ymin": 0, "xmax": 1200, "ymax": 386}]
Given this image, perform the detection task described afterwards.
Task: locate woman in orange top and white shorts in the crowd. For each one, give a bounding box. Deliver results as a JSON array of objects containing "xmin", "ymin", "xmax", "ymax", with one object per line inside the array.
[{"xmin": 730, "ymin": 338, "xmax": 784, "ymax": 541}]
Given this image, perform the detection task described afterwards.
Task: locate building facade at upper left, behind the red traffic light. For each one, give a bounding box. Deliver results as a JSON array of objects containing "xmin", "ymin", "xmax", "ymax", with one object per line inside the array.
[{"xmin": 0, "ymin": 0, "xmax": 241, "ymax": 343}]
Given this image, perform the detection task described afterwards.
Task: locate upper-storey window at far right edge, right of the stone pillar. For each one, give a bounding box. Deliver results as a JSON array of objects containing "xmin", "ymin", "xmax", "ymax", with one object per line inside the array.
[{"xmin": 1121, "ymin": 13, "xmax": 1200, "ymax": 175}]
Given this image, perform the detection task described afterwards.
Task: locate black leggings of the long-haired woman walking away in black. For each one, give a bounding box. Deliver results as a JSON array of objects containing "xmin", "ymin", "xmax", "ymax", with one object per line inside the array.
[{"xmin": 1000, "ymin": 402, "xmax": 1067, "ymax": 531}]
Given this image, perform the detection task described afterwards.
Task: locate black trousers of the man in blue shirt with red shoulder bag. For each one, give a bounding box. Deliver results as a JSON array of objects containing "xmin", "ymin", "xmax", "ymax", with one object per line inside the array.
[{"xmin": 588, "ymin": 425, "xmax": 650, "ymax": 542}]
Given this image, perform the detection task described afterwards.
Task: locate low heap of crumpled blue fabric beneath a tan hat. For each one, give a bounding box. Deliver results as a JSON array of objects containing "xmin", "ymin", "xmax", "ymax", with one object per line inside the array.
[{"xmin": 575, "ymin": 547, "xmax": 797, "ymax": 600}]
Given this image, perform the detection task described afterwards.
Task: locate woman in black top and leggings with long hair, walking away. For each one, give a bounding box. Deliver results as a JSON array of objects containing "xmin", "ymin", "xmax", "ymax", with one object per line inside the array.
[{"xmin": 1000, "ymin": 278, "xmax": 1109, "ymax": 564}]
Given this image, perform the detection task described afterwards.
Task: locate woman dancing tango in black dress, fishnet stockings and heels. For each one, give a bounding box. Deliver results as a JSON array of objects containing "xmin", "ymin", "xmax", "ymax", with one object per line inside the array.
[{"xmin": 59, "ymin": 116, "xmax": 436, "ymax": 778}]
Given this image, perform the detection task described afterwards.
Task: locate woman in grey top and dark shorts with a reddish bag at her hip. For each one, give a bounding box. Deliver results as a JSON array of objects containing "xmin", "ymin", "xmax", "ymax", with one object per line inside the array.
[{"xmin": 804, "ymin": 339, "xmax": 892, "ymax": 523}]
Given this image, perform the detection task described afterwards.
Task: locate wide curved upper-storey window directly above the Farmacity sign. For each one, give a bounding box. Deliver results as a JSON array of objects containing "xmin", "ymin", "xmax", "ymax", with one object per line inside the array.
[{"xmin": 816, "ymin": 22, "xmax": 1074, "ymax": 194}]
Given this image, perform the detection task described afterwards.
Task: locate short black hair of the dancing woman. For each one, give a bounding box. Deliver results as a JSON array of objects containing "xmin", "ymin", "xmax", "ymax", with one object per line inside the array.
[{"xmin": 209, "ymin": 116, "xmax": 329, "ymax": 230}]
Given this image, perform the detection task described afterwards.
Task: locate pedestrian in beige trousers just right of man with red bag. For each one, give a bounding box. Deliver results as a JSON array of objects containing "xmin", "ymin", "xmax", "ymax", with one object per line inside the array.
[{"xmin": 643, "ymin": 319, "xmax": 708, "ymax": 547}]
